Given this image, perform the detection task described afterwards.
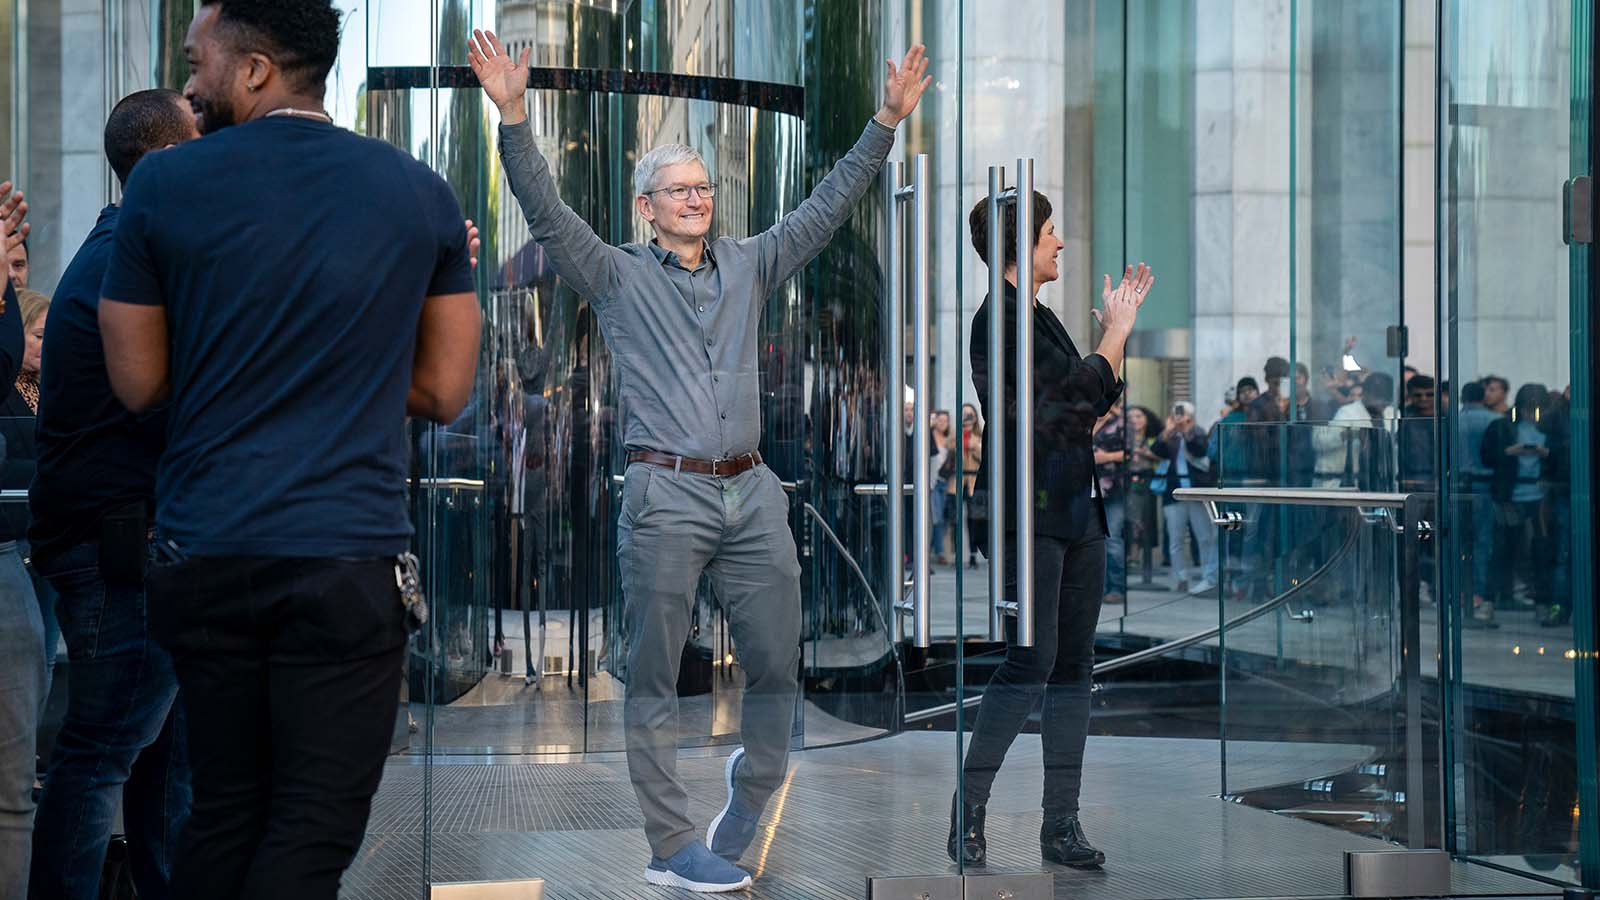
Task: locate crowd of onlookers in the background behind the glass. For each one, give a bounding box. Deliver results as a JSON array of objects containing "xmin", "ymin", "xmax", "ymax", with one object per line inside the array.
[{"xmin": 907, "ymin": 344, "xmax": 1571, "ymax": 628}]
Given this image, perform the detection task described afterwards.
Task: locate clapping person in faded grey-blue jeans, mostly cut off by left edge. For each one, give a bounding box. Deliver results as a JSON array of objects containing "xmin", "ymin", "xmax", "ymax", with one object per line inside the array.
[{"xmin": 0, "ymin": 181, "xmax": 46, "ymax": 900}]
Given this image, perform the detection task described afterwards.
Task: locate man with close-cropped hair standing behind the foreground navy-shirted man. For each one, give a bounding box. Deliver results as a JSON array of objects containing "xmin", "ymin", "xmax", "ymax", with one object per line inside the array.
[{"xmin": 29, "ymin": 90, "xmax": 200, "ymax": 900}]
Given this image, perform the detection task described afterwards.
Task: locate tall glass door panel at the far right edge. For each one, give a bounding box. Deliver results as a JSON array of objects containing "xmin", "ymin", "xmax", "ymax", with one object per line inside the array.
[{"xmin": 1437, "ymin": 0, "xmax": 1600, "ymax": 887}]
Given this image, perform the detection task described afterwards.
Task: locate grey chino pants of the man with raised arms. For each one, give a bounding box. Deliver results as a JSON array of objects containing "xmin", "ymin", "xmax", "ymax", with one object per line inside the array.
[{"xmin": 618, "ymin": 463, "xmax": 800, "ymax": 858}]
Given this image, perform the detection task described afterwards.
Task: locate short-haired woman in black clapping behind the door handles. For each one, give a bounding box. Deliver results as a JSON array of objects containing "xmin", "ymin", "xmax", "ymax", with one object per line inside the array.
[{"xmin": 946, "ymin": 192, "xmax": 1155, "ymax": 868}]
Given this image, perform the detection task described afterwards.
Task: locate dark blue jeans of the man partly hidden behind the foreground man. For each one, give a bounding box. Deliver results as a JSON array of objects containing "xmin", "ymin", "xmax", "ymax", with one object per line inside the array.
[{"xmin": 34, "ymin": 543, "xmax": 190, "ymax": 900}]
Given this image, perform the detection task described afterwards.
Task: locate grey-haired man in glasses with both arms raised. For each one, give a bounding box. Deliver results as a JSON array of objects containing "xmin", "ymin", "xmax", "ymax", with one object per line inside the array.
[{"xmin": 470, "ymin": 32, "xmax": 931, "ymax": 892}]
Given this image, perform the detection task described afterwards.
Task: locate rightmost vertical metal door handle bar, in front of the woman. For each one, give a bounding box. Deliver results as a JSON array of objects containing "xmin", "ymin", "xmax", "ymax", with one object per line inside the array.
[{"xmin": 1016, "ymin": 159, "xmax": 1036, "ymax": 647}]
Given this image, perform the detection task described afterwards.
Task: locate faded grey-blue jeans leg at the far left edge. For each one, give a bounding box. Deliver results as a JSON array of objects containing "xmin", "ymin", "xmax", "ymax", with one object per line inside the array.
[{"xmin": 0, "ymin": 541, "xmax": 45, "ymax": 900}]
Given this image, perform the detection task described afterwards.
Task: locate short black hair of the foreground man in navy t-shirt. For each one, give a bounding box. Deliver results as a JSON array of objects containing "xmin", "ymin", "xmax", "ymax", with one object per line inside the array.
[{"xmin": 205, "ymin": 0, "xmax": 339, "ymax": 96}]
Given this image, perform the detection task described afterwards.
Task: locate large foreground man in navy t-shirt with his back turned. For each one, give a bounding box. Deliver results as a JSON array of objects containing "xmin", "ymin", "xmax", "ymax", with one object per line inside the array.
[{"xmin": 99, "ymin": 0, "xmax": 480, "ymax": 900}]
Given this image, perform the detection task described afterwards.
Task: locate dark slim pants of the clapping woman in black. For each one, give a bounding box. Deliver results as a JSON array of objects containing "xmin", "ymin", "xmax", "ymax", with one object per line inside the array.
[{"xmin": 962, "ymin": 516, "xmax": 1106, "ymax": 825}]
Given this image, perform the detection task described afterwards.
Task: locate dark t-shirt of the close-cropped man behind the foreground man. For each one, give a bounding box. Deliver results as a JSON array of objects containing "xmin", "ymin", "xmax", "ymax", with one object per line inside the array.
[{"xmin": 27, "ymin": 207, "xmax": 166, "ymax": 562}]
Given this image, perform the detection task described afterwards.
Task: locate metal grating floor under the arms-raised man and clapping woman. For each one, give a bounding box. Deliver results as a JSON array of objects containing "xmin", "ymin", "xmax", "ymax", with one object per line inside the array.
[{"xmin": 341, "ymin": 732, "xmax": 1554, "ymax": 900}]
